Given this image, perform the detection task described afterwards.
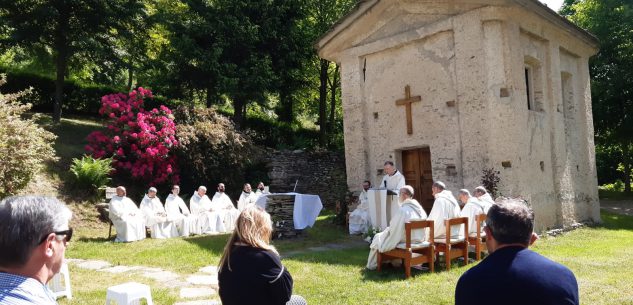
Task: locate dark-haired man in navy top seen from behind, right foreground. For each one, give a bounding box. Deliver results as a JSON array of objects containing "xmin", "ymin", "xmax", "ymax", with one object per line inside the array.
[{"xmin": 455, "ymin": 199, "xmax": 579, "ymax": 305}]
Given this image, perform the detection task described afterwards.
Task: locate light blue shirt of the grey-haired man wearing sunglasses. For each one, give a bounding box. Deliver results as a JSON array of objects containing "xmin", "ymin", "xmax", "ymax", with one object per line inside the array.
[{"xmin": 0, "ymin": 272, "xmax": 57, "ymax": 305}]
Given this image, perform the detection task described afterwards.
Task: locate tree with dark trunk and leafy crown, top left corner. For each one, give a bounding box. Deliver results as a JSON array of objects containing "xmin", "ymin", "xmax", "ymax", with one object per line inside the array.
[{"xmin": 0, "ymin": 0, "xmax": 143, "ymax": 122}]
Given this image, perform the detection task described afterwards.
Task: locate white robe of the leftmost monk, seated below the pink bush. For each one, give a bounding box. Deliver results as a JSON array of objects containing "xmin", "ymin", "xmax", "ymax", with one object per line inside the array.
[{"xmin": 109, "ymin": 196, "xmax": 145, "ymax": 242}]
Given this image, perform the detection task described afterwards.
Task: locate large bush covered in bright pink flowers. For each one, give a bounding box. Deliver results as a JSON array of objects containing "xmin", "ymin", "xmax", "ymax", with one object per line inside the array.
[{"xmin": 86, "ymin": 87, "xmax": 180, "ymax": 186}]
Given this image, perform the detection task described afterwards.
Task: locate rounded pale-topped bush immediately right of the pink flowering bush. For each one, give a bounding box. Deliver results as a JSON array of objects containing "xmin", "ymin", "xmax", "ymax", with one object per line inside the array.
[{"xmin": 174, "ymin": 107, "xmax": 255, "ymax": 194}]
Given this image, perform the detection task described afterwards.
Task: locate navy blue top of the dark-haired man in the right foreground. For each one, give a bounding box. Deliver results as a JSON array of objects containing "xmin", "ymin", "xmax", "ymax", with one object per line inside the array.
[{"xmin": 455, "ymin": 246, "xmax": 579, "ymax": 305}]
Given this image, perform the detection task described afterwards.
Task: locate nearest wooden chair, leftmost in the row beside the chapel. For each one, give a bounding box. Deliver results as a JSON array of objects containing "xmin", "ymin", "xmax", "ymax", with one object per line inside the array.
[{"xmin": 378, "ymin": 220, "xmax": 435, "ymax": 278}]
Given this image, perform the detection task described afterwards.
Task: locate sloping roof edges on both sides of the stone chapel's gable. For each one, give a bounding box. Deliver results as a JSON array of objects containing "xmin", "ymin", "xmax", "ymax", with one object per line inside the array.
[{"xmin": 314, "ymin": 0, "xmax": 599, "ymax": 54}]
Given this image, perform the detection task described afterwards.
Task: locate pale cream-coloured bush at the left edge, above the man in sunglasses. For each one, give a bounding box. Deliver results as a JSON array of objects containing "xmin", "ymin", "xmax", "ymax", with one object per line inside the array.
[{"xmin": 0, "ymin": 75, "xmax": 57, "ymax": 198}]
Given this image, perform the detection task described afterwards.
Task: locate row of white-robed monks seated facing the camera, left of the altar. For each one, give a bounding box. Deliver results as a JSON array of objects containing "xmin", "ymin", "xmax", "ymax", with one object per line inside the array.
[{"xmin": 109, "ymin": 182, "xmax": 264, "ymax": 242}]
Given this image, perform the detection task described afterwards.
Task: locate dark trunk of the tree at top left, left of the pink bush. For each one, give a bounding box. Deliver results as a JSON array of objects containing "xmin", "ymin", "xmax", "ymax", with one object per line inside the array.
[{"xmin": 53, "ymin": 7, "xmax": 70, "ymax": 123}]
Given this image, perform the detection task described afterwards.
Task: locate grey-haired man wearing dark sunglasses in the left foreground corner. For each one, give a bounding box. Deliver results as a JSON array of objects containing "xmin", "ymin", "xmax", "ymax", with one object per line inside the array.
[{"xmin": 0, "ymin": 196, "xmax": 73, "ymax": 305}]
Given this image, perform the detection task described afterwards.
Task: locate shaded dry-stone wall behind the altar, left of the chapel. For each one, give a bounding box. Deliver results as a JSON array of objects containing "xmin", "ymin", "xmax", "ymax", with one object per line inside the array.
[{"xmin": 264, "ymin": 150, "xmax": 348, "ymax": 208}]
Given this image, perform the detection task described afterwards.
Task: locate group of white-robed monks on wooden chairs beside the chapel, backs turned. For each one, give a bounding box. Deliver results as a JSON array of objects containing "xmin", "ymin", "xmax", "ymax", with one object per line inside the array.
[{"xmin": 363, "ymin": 181, "xmax": 495, "ymax": 270}]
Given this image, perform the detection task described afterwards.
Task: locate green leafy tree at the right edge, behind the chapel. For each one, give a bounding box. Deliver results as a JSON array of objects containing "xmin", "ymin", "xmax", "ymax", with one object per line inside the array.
[{"xmin": 562, "ymin": 0, "xmax": 633, "ymax": 193}]
